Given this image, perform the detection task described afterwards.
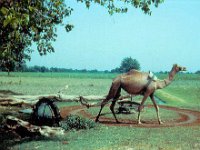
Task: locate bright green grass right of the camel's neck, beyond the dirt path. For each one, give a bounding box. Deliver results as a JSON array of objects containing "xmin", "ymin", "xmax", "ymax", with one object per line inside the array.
[{"xmin": 156, "ymin": 74, "xmax": 200, "ymax": 111}]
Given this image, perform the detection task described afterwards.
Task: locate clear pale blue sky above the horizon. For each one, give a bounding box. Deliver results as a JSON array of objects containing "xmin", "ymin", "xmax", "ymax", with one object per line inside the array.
[{"xmin": 28, "ymin": 0, "xmax": 200, "ymax": 72}]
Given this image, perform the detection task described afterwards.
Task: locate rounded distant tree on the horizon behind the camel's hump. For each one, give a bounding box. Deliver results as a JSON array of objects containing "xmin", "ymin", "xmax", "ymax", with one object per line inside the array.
[{"xmin": 111, "ymin": 57, "xmax": 140, "ymax": 72}]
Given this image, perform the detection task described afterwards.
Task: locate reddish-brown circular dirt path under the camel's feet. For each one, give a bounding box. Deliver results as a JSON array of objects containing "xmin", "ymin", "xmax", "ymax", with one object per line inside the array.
[{"xmin": 61, "ymin": 106, "xmax": 200, "ymax": 128}]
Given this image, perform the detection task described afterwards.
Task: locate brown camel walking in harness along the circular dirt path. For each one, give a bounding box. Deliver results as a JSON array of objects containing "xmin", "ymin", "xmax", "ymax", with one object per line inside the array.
[{"xmin": 95, "ymin": 64, "xmax": 186, "ymax": 124}]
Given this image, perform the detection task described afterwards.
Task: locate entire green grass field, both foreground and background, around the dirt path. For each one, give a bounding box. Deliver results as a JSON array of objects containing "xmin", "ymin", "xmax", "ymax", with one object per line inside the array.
[{"xmin": 0, "ymin": 73, "xmax": 200, "ymax": 150}]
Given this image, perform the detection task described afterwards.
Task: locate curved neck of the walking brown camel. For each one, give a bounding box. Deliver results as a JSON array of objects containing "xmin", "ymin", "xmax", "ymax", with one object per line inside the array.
[{"xmin": 157, "ymin": 68, "xmax": 176, "ymax": 89}]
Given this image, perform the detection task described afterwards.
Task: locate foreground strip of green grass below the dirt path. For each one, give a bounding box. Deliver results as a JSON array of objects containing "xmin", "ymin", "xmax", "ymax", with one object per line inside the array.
[{"xmin": 10, "ymin": 126, "xmax": 200, "ymax": 150}]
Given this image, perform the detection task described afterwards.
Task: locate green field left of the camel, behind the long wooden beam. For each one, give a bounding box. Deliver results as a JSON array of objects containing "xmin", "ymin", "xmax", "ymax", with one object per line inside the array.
[{"xmin": 0, "ymin": 73, "xmax": 112, "ymax": 95}]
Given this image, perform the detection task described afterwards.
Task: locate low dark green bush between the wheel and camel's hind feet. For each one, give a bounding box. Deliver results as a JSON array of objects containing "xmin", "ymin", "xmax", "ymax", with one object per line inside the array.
[{"xmin": 61, "ymin": 115, "xmax": 96, "ymax": 130}]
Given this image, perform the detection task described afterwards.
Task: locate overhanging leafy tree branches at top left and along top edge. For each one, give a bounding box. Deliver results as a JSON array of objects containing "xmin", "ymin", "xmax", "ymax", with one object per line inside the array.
[{"xmin": 0, "ymin": 0, "xmax": 163, "ymax": 68}]
